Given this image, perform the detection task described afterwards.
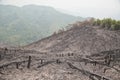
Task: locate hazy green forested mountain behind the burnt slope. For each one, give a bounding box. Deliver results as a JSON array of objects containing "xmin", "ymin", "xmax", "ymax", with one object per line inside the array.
[{"xmin": 0, "ymin": 5, "xmax": 85, "ymax": 45}]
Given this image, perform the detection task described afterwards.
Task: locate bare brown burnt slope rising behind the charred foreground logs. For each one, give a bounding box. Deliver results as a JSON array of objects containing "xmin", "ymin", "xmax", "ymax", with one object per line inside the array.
[{"xmin": 26, "ymin": 22, "xmax": 120, "ymax": 54}]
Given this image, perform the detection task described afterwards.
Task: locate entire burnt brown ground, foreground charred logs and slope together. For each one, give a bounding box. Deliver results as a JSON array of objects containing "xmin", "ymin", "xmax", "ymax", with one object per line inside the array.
[{"xmin": 0, "ymin": 22, "xmax": 120, "ymax": 80}]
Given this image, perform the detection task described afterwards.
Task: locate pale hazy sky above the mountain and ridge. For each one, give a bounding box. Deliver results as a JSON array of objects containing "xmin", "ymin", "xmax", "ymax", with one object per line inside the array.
[{"xmin": 0, "ymin": 0, "xmax": 120, "ymax": 20}]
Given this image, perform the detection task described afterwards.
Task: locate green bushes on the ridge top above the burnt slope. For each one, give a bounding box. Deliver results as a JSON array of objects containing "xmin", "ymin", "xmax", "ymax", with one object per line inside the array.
[{"xmin": 93, "ymin": 18, "xmax": 120, "ymax": 30}]
